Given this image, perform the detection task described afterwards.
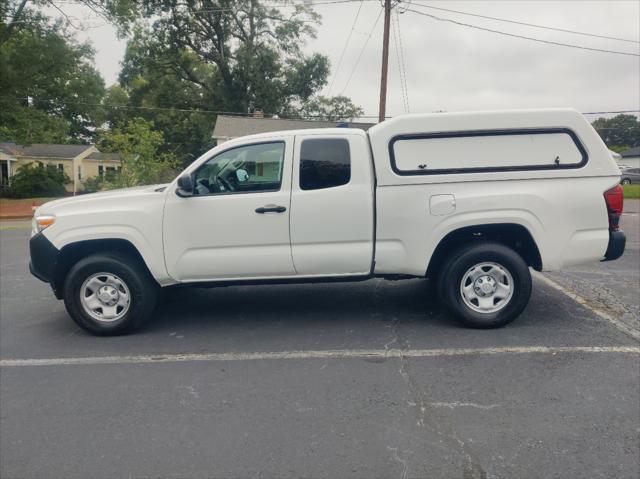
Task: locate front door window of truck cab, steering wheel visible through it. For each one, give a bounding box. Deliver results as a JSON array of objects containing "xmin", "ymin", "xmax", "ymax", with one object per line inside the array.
[{"xmin": 195, "ymin": 141, "xmax": 285, "ymax": 195}]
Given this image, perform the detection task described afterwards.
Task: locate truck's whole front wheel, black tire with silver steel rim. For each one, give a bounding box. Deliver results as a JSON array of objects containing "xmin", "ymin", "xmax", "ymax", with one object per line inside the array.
[{"xmin": 64, "ymin": 252, "xmax": 158, "ymax": 336}]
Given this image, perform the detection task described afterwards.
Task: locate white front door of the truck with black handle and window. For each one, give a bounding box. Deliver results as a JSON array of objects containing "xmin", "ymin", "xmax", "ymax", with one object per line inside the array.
[{"xmin": 163, "ymin": 137, "xmax": 295, "ymax": 282}]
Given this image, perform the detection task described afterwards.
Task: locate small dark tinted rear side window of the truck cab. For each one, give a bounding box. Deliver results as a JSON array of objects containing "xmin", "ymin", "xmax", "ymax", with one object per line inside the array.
[{"xmin": 300, "ymin": 138, "xmax": 351, "ymax": 190}]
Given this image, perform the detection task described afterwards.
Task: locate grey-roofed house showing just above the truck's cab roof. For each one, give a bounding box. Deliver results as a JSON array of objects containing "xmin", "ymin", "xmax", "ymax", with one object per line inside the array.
[{"xmin": 213, "ymin": 112, "xmax": 375, "ymax": 145}]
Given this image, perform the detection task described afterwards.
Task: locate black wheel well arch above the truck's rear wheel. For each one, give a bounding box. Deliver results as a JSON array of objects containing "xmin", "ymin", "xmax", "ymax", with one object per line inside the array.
[{"xmin": 427, "ymin": 223, "xmax": 542, "ymax": 276}]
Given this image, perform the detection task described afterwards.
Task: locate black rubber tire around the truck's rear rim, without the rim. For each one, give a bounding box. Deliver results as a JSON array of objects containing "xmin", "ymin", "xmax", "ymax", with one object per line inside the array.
[{"xmin": 438, "ymin": 242, "xmax": 531, "ymax": 329}]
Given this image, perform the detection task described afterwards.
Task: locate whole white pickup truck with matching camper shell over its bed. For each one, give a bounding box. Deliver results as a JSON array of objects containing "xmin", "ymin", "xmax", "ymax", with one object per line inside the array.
[{"xmin": 30, "ymin": 109, "xmax": 625, "ymax": 335}]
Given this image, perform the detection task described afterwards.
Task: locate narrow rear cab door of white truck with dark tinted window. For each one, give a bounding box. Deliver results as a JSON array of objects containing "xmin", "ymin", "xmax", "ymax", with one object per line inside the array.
[{"xmin": 290, "ymin": 130, "xmax": 374, "ymax": 276}]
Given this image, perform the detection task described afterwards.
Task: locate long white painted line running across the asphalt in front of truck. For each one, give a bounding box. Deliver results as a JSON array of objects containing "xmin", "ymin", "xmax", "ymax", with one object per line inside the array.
[{"xmin": 0, "ymin": 346, "xmax": 640, "ymax": 367}]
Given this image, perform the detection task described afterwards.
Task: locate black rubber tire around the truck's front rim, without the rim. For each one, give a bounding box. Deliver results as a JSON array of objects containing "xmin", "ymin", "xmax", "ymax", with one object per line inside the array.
[{"xmin": 64, "ymin": 252, "xmax": 158, "ymax": 336}]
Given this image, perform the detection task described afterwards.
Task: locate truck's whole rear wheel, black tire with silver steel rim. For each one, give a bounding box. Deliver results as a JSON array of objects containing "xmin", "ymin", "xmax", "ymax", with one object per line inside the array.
[{"xmin": 438, "ymin": 242, "xmax": 531, "ymax": 329}]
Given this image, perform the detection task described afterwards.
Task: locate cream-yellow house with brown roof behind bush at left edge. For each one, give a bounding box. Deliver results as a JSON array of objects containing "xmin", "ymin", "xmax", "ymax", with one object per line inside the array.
[{"xmin": 0, "ymin": 142, "xmax": 121, "ymax": 193}]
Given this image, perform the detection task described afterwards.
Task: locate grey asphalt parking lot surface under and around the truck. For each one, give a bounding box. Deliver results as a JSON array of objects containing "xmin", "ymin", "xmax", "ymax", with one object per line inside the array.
[{"xmin": 0, "ymin": 202, "xmax": 640, "ymax": 479}]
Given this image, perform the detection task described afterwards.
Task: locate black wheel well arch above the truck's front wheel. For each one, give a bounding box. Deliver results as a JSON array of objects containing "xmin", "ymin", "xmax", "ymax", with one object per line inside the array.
[{"xmin": 52, "ymin": 239, "xmax": 153, "ymax": 299}]
